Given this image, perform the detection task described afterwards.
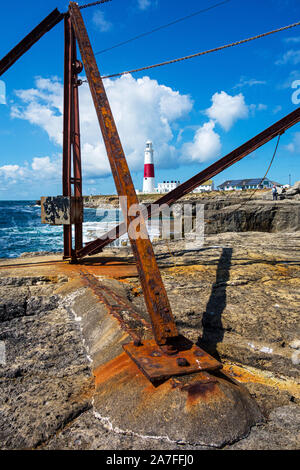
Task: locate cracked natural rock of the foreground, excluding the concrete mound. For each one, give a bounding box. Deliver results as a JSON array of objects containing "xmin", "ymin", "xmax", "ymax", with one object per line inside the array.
[{"xmin": 0, "ymin": 232, "xmax": 300, "ymax": 450}]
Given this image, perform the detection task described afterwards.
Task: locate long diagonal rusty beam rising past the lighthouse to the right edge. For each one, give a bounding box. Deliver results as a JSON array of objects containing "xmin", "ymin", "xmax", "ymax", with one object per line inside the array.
[{"xmin": 76, "ymin": 108, "xmax": 300, "ymax": 258}]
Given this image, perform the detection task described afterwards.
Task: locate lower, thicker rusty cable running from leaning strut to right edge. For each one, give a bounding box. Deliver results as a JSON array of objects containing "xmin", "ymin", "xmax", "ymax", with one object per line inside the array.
[{"xmin": 102, "ymin": 21, "xmax": 300, "ymax": 79}]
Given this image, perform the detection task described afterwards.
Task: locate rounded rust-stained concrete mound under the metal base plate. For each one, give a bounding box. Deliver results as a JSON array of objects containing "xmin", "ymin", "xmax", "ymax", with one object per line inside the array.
[{"xmin": 94, "ymin": 353, "xmax": 263, "ymax": 448}]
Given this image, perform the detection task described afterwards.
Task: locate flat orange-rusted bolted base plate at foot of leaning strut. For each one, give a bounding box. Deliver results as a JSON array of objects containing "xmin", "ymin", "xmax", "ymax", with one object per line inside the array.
[{"xmin": 123, "ymin": 337, "xmax": 223, "ymax": 381}]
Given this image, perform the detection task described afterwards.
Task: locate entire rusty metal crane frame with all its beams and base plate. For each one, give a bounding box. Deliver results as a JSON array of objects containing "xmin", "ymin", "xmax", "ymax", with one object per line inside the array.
[{"xmin": 0, "ymin": 2, "xmax": 300, "ymax": 381}]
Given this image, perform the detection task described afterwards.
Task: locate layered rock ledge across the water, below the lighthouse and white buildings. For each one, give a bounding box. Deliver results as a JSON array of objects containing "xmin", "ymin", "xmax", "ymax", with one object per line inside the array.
[{"xmin": 84, "ymin": 183, "xmax": 300, "ymax": 235}]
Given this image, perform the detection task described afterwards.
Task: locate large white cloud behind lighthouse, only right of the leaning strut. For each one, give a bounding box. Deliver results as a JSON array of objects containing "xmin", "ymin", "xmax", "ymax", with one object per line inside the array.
[{"xmin": 106, "ymin": 73, "xmax": 193, "ymax": 169}]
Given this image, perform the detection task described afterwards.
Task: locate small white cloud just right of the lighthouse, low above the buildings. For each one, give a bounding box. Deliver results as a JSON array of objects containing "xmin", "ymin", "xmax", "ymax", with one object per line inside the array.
[{"xmin": 182, "ymin": 121, "xmax": 221, "ymax": 162}]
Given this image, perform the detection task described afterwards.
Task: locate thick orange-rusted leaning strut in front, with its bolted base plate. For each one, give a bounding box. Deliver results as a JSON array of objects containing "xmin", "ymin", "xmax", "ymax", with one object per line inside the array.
[{"xmin": 69, "ymin": 2, "xmax": 222, "ymax": 380}]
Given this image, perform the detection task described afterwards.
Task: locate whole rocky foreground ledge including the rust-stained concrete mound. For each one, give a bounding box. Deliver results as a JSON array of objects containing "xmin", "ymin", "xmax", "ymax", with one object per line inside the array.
[{"xmin": 0, "ymin": 234, "xmax": 300, "ymax": 450}]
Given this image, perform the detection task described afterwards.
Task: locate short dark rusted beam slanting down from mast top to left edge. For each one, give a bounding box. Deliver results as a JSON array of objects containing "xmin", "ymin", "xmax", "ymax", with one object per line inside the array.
[{"xmin": 0, "ymin": 8, "xmax": 64, "ymax": 76}]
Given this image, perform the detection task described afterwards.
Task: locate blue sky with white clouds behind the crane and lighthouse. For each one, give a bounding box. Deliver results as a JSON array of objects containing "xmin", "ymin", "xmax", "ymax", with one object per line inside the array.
[{"xmin": 0, "ymin": 0, "xmax": 300, "ymax": 200}]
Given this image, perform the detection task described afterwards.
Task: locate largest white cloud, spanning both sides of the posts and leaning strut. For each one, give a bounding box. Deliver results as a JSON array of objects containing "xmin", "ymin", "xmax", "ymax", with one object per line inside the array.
[{"xmin": 11, "ymin": 75, "xmax": 193, "ymax": 177}]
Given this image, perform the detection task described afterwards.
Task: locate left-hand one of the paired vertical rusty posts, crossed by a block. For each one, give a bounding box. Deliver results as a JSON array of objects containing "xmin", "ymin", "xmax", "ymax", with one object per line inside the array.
[{"xmin": 62, "ymin": 16, "xmax": 74, "ymax": 259}]
